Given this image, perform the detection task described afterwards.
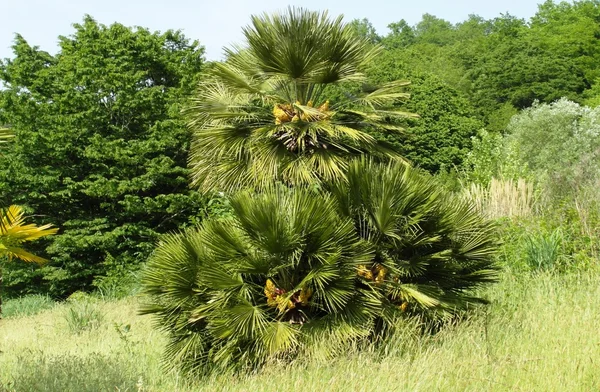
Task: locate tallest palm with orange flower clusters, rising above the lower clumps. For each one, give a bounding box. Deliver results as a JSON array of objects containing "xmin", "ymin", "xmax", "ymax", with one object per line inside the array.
[{"xmin": 186, "ymin": 8, "xmax": 415, "ymax": 191}]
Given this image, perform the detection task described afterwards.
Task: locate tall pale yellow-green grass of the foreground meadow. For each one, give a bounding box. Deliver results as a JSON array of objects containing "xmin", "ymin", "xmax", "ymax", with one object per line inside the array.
[{"xmin": 0, "ymin": 272, "xmax": 600, "ymax": 391}]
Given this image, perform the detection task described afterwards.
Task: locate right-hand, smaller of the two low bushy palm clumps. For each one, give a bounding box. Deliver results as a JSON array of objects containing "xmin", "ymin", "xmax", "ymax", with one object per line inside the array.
[{"xmin": 333, "ymin": 160, "xmax": 498, "ymax": 320}]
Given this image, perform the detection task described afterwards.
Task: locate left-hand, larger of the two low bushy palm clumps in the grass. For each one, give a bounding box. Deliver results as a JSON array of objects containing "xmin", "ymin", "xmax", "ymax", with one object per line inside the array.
[{"xmin": 142, "ymin": 188, "xmax": 381, "ymax": 374}]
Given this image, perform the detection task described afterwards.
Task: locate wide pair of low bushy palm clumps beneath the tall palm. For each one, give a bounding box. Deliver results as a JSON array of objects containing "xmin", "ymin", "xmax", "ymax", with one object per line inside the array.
[{"xmin": 142, "ymin": 163, "xmax": 496, "ymax": 374}]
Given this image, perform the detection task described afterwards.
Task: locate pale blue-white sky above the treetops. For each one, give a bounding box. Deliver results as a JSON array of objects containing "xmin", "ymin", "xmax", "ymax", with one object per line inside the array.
[{"xmin": 0, "ymin": 0, "xmax": 543, "ymax": 60}]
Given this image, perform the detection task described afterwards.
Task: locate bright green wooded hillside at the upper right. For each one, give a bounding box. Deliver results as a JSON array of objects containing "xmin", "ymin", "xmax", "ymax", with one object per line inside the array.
[{"xmin": 382, "ymin": 0, "xmax": 600, "ymax": 132}]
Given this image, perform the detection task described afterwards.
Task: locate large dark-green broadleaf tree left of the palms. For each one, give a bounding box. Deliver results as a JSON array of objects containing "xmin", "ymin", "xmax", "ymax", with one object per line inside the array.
[{"xmin": 0, "ymin": 16, "xmax": 205, "ymax": 296}]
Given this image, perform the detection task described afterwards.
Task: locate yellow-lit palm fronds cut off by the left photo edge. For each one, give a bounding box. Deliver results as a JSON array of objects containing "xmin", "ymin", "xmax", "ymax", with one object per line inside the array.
[{"xmin": 0, "ymin": 205, "xmax": 58, "ymax": 314}]
